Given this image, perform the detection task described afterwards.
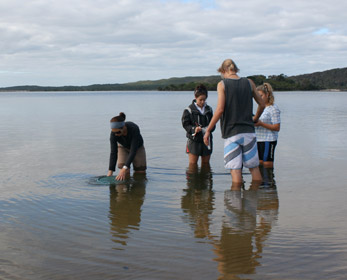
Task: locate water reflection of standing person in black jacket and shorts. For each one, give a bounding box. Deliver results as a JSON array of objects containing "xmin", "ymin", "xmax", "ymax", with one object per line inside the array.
[{"xmin": 181, "ymin": 164, "xmax": 214, "ymax": 238}]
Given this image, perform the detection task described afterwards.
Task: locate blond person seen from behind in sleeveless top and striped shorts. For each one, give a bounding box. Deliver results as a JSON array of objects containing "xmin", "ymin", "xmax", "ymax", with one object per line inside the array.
[{"xmin": 204, "ymin": 59, "xmax": 265, "ymax": 189}]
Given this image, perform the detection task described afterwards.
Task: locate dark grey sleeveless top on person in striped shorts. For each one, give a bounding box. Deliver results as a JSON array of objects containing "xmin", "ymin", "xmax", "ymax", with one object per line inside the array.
[{"xmin": 221, "ymin": 78, "xmax": 254, "ymax": 139}]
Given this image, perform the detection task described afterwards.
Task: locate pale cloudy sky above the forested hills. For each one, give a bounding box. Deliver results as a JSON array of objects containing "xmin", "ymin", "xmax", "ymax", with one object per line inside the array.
[{"xmin": 0, "ymin": 0, "xmax": 347, "ymax": 87}]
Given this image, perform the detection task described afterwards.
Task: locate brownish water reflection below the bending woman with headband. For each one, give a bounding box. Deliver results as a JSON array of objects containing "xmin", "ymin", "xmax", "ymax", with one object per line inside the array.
[{"xmin": 109, "ymin": 174, "xmax": 147, "ymax": 249}]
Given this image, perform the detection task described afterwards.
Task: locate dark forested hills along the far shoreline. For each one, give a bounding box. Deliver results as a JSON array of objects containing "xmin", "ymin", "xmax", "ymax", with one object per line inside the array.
[{"xmin": 0, "ymin": 67, "xmax": 347, "ymax": 91}]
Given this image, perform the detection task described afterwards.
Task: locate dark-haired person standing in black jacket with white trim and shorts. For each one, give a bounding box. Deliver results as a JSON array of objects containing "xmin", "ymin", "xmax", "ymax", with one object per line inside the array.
[{"xmin": 182, "ymin": 84, "xmax": 214, "ymax": 164}]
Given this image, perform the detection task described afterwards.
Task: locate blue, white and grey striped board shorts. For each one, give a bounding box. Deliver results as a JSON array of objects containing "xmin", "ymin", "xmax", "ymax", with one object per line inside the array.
[{"xmin": 224, "ymin": 133, "xmax": 259, "ymax": 169}]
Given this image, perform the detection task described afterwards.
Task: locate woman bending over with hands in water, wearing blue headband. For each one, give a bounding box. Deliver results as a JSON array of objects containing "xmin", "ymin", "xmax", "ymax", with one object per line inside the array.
[{"xmin": 107, "ymin": 113, "xmax": 147, "ymax": 180}]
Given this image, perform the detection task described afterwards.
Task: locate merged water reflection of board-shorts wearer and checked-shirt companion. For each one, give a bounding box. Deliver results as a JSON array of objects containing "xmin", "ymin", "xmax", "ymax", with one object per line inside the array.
[{"xmin": 214, "ymin": 180, "xmax": 279, "ymax": 279}]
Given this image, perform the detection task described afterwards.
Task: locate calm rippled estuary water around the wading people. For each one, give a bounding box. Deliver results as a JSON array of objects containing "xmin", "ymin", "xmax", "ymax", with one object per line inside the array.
[{"xmin": 0, "ymin": 92, "xmax": 347, "ymax": 280}]
